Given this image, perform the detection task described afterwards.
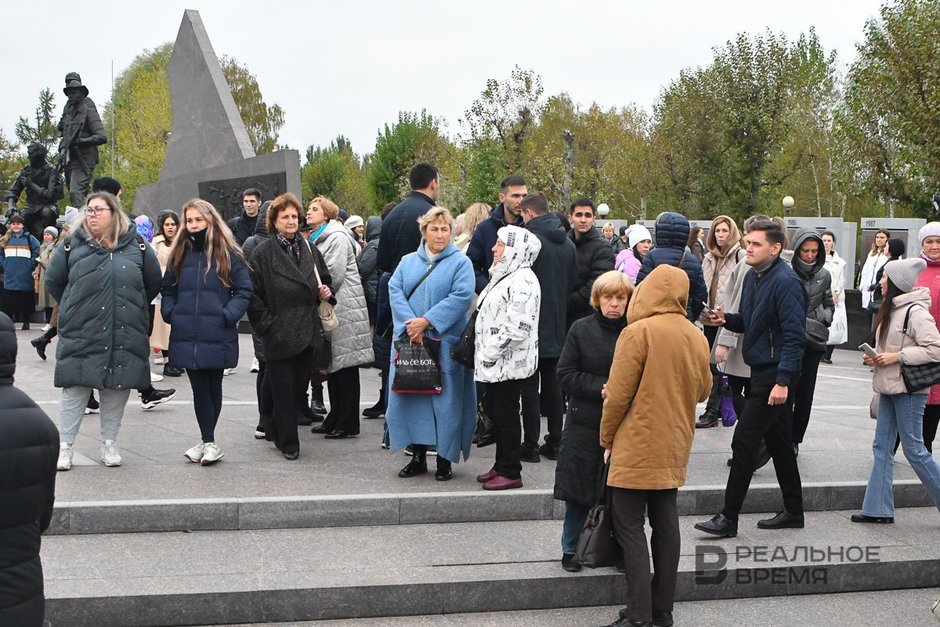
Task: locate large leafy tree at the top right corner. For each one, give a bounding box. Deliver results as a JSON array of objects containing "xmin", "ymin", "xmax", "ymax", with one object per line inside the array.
[{"xmin": 837, "ymin": 0, "xmax": 940, "ymax": 214}]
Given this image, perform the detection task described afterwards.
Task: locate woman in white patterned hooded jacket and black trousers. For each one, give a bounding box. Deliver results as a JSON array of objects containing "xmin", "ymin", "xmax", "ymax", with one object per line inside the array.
[{"xmin": 474, "ymin": 226, "xmax": 542, "ymax": 490}]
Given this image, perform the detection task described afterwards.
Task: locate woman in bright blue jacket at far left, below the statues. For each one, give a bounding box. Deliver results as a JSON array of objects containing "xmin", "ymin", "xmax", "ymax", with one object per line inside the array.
[{"xmin": 0, "ymin": 213, "xmax": 39, "ymax": 331}]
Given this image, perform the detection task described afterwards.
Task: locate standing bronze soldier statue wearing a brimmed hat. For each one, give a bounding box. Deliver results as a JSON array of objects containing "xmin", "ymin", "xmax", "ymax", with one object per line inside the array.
[{"xmin": 58, "ymin": 72, "xmax": 108, "ymax": 207}]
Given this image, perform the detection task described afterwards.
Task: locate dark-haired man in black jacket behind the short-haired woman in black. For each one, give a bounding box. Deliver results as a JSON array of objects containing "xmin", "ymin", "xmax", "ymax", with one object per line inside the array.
[{"xmin": 568, "ymin": 198, "xmax": 614, "ymax": 327}]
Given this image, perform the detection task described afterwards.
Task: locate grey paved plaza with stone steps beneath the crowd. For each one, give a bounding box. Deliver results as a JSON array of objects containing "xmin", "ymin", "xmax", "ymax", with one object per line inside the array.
[{"xmin": 22, "ymin": 332, "xmax": 940, "ymax": 626}]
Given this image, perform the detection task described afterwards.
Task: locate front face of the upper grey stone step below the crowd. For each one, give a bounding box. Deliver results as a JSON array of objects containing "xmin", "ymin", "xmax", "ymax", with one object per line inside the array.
[{"xmin": 47, "ymin": 480, "xmax": 932, "ymax": 535}]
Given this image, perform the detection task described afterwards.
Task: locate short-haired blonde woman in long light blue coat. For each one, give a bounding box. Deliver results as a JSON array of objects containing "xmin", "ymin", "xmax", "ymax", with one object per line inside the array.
[{"xmin": 385, "ymin": 207, "xmax": 477, "ymax": 481}]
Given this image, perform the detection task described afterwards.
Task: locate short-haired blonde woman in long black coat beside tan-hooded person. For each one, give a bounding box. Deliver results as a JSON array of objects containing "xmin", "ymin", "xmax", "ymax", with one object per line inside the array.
[{"xmin": 555, "ymin": 270, "xmax": 633, "ymax": 572}]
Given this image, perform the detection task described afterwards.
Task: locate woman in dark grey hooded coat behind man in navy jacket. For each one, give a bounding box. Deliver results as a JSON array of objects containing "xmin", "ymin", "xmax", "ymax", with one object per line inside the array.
[{"xmin": 790, "ymin": 229, "xmax": 836, "ymax": 453}]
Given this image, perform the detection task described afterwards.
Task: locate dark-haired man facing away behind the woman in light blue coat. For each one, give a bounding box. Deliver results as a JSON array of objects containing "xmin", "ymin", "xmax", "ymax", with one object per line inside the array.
[{"xmin": 376, "ymin": 163, "xmax": 441, "ymax": 276}]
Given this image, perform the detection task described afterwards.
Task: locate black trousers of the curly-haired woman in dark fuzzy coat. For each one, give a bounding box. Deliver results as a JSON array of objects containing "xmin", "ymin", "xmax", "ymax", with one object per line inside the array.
[{"xmin": 264, "ymin": 346, "xmax": 313, "ymax": 453}]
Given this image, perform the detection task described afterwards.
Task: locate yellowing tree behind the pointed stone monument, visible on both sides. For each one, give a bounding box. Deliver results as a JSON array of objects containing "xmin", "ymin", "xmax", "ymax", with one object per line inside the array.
[{"xmin": 95, "ymin": 43, "xmax": 284, "ymax": 206}]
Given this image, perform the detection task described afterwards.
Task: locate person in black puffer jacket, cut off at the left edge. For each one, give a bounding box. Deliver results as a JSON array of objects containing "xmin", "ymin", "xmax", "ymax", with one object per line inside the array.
[{"xmin": 0, "ymin": 313, "xmax": 59, "ymax": 626}]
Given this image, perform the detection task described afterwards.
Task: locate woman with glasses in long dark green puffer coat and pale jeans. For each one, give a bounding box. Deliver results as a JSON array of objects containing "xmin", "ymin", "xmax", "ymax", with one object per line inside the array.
[{"xmin": 46, "ymin": 192, "xmax": 161, "ymax": 470}]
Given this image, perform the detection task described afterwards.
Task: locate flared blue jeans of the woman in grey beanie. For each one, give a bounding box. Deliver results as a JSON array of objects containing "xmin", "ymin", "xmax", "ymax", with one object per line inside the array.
[{"xmin": 862, "ymin": 394, "xmax": 940, "ymax": 517}]
